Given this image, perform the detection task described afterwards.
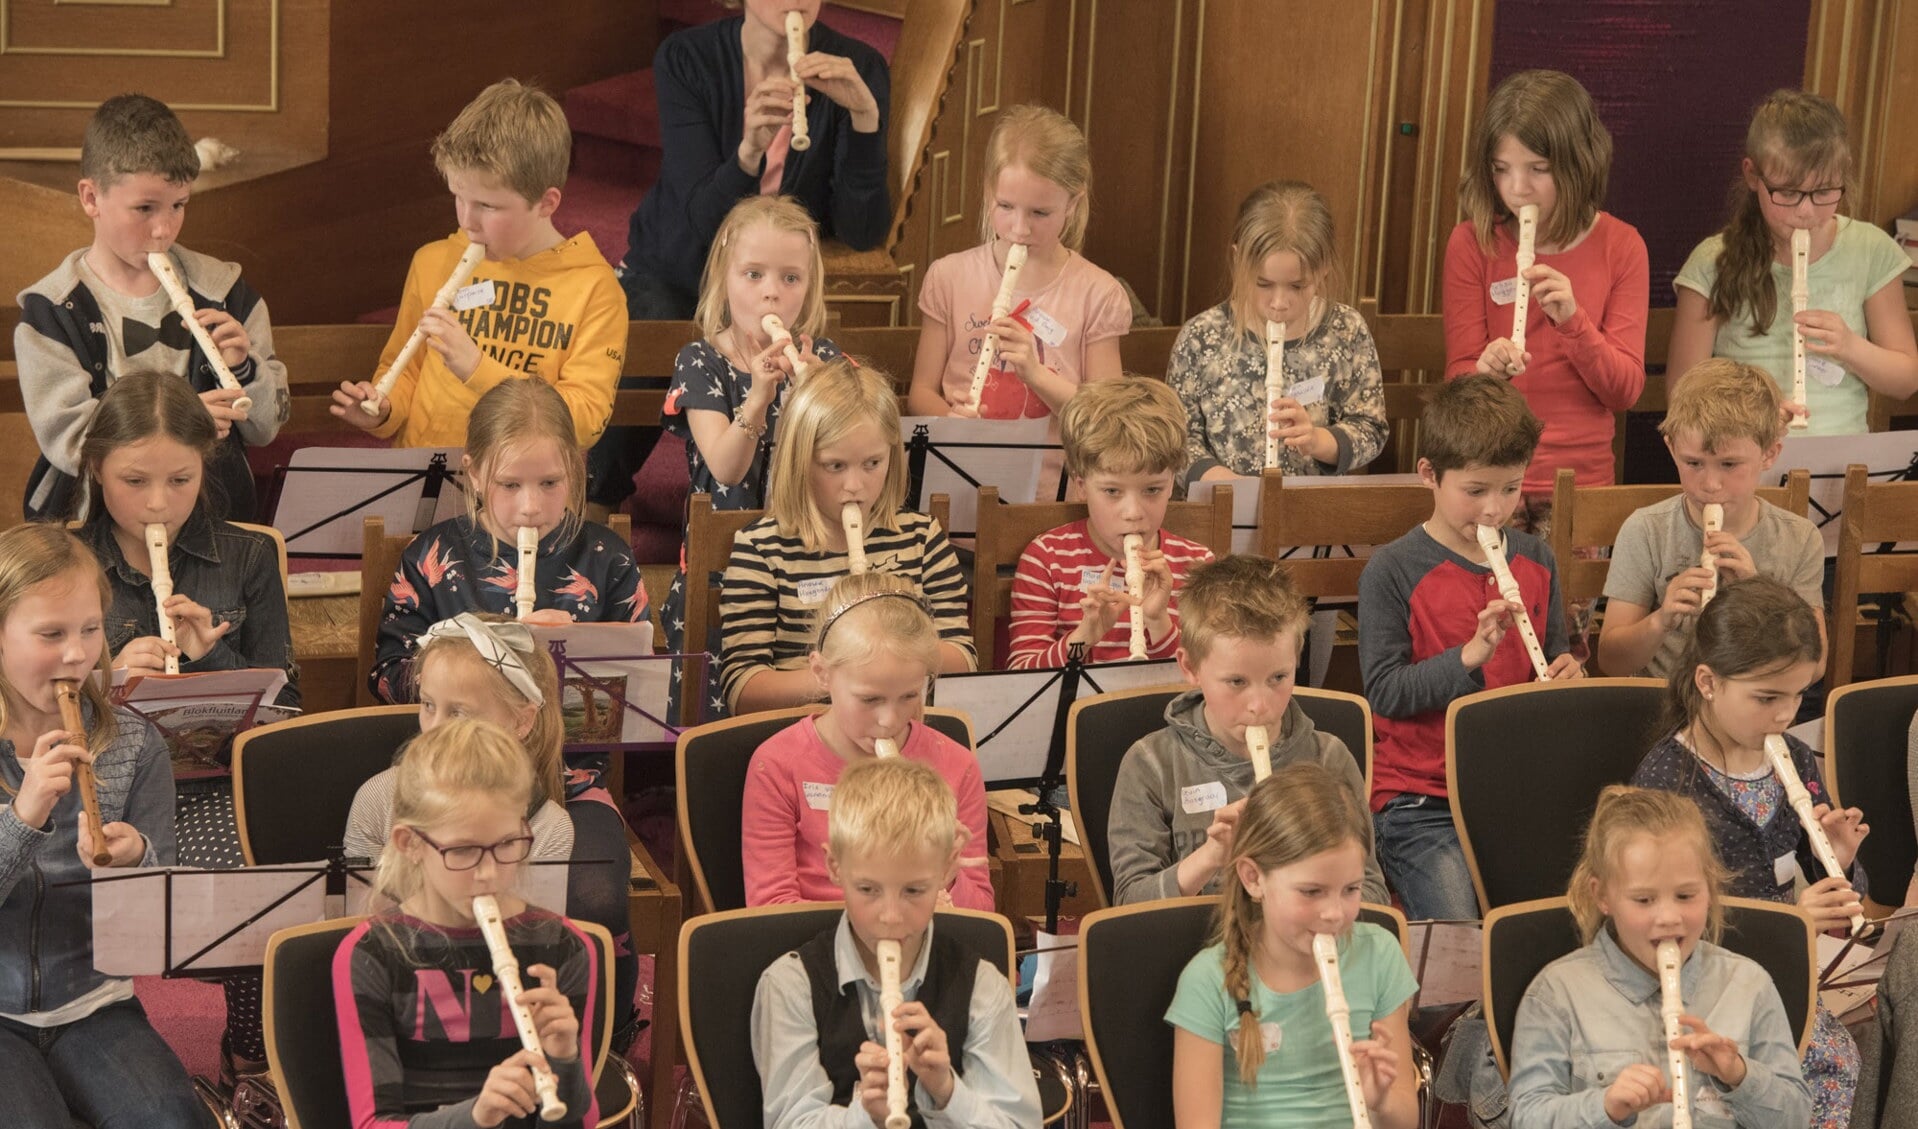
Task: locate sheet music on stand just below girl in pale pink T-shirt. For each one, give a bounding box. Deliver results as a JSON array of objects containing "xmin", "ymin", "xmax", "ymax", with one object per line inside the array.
[{"xmin": 900, "ymin": 416, "xmax": 1059, "ymax": 539}]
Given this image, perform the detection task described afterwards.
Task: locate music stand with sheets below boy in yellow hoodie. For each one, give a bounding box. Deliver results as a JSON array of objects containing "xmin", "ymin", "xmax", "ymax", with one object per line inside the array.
[{"xmin": 272, "ymin": 447, "xmax": 466, "ymax": 560}]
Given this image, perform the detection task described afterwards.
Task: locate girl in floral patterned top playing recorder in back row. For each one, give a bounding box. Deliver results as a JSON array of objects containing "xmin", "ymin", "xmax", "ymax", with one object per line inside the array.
[{"xmin": 1166, "ymin": 180, "xmax": 1385, "ymax": 481}]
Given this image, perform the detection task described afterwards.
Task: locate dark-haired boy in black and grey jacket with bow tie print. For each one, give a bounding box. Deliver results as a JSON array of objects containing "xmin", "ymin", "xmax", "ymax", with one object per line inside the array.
[{"xmin": 13, "ymin": 94, "xmax": 290, "ymax": 521}]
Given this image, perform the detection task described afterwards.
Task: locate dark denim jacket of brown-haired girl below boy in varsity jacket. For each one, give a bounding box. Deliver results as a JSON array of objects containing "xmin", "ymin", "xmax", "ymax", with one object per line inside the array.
[{"xmin": 79, "ymin": 506, "xmax": 299, "ymax": 705}]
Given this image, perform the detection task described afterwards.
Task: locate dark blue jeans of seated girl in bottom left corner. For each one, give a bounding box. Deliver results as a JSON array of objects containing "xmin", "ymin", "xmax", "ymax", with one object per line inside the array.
[{"xmin": 0, "ymin": 1001, "xmax": 211, "ymax": 1129}]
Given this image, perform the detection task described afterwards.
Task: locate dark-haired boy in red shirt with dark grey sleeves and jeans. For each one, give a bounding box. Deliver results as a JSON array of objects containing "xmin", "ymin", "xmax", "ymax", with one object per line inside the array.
[{"xmin": 1358, "ymin": 374, "xmax": 1582, "ymax": 920}]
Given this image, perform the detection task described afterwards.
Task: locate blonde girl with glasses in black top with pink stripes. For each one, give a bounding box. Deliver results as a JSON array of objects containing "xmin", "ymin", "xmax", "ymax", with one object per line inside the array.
[{"xmin": 334, "ymin": 719, "xmax": 602, "ymax": 1129}]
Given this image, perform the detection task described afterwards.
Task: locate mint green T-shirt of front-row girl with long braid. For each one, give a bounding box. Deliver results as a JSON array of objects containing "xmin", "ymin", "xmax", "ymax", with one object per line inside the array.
[{"xmin": 1166, "ymin": 922, "xmax": 1419, "ymax": 1129}]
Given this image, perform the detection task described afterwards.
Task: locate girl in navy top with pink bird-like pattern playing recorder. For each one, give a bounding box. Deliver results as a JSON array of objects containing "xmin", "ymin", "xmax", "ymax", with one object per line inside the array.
[{"xmin": 368, "ymin": 380, "xmax": 646, "ymax": 702}]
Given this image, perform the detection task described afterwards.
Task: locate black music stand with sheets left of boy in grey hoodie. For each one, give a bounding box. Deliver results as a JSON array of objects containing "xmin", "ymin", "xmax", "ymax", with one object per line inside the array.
[{"xmin": 930, "ymin": 642, "xmax": 1183, "ymax": 933}]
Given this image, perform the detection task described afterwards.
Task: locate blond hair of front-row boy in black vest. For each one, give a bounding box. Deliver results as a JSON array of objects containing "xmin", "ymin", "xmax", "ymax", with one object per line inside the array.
[{"xmin": 827, "ymin": 757, "xmax": 963, "ymax": 864}]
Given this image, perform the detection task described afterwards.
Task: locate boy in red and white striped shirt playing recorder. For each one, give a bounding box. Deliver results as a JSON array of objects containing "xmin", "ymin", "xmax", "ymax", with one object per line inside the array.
[{"xmin": 1007, "ymin": 378, "xmax": 1212, "ymax": 669}]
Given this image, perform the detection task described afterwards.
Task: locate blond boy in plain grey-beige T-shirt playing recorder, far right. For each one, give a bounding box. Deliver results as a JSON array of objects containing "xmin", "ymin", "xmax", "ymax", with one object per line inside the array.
[{"xmin": 1598, "ymin": 357, "xmax": 1824, "ymax": 679}]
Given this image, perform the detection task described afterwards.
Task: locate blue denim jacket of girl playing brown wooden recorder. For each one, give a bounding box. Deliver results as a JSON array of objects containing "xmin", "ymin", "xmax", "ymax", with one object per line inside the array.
[{"xmin": 0, "ymin": 700, "xmax": 175, "ymax": 1016}]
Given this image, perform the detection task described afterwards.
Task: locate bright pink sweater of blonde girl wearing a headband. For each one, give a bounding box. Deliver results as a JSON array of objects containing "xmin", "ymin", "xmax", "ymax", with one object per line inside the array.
[{"xmin": 740, "ymin": 717, "xmax": 994, "ymax": 912}]
